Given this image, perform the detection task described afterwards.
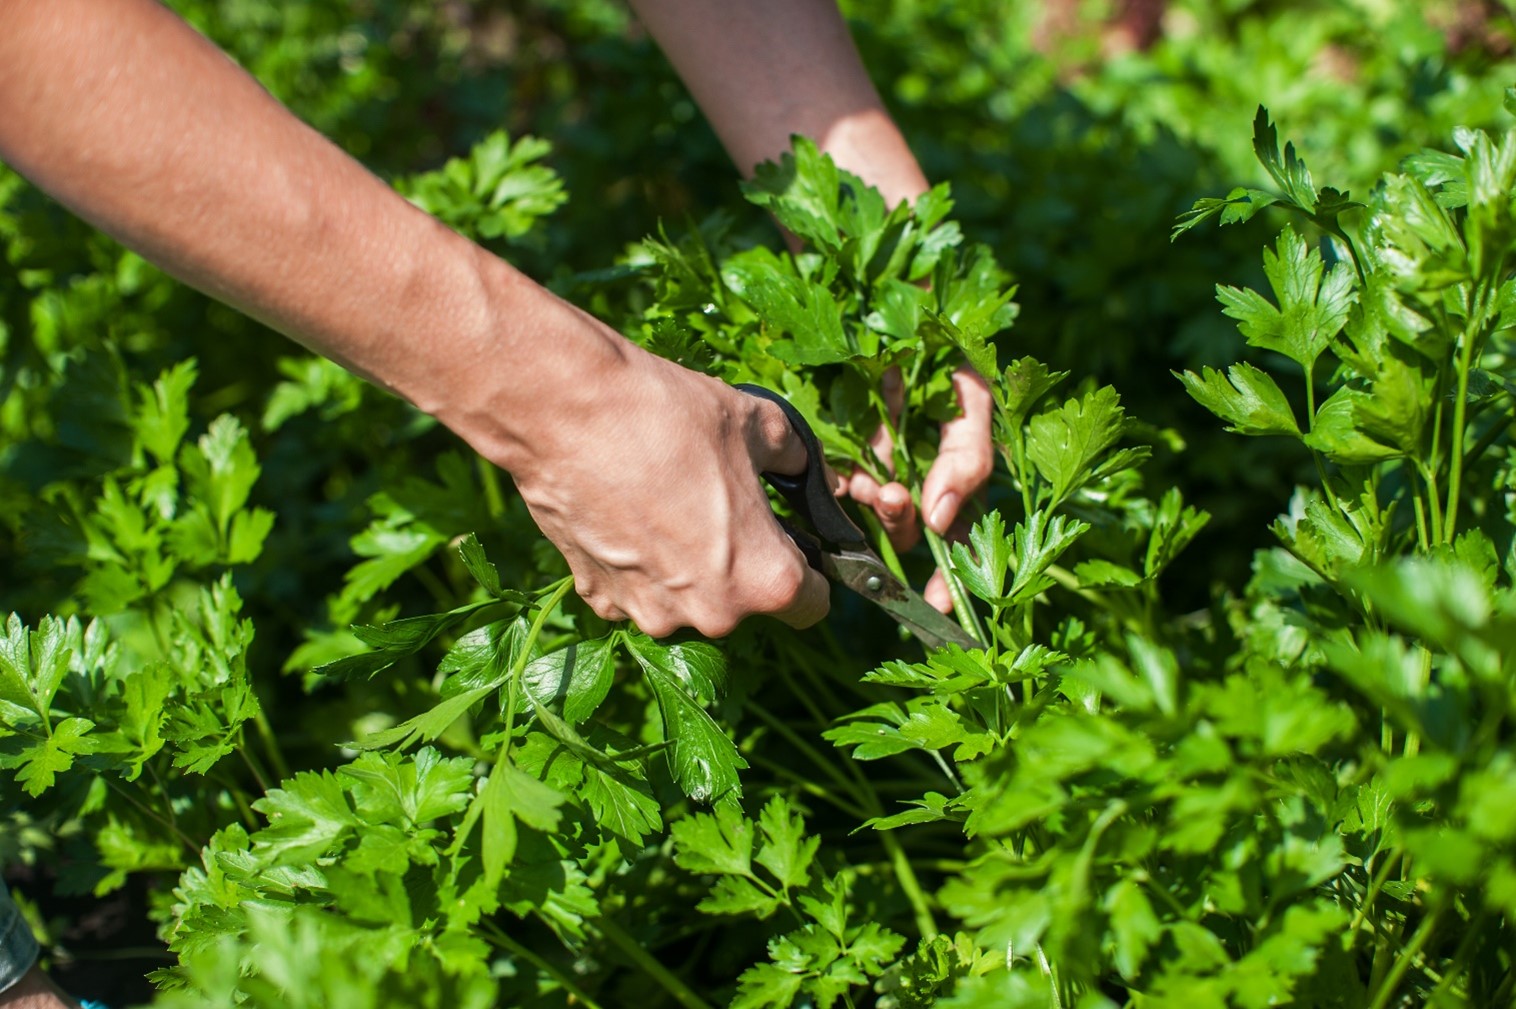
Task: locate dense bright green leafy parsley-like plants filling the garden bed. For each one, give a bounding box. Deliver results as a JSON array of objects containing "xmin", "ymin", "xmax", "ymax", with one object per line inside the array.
[{"xmin": 0, "ymin": 0, "xmax": 1516, "ymax": 1009}]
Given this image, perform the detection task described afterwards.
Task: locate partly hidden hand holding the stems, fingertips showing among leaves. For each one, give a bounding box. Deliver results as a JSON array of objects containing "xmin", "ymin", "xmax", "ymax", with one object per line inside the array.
[{"xmin": 838, "ymin": 365, "xmax": 994, "ymax": 614}]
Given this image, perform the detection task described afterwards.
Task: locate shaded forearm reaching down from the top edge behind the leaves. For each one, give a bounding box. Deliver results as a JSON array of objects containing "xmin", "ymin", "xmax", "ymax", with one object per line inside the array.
[{"xmin": 632, "ymin": 0, "xmax": 926, "ymax": 203}]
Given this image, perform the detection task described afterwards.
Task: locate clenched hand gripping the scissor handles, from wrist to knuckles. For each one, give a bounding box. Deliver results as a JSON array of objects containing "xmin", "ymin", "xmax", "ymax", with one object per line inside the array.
[{"xmin": 488, "ymin": 314, "xmax": 829, "ymax": 638}]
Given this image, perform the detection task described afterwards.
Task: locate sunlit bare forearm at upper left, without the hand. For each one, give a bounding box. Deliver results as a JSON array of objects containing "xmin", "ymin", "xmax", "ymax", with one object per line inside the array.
[{"xmin": 0, "ymin": 0, "xmax": 619, "ymax": 465}]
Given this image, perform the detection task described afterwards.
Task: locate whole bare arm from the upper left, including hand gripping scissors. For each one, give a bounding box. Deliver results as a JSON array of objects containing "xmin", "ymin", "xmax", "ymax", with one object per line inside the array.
[{"xmin": 0, "ymin": 0, "xmax": 826, "ymax": 635}]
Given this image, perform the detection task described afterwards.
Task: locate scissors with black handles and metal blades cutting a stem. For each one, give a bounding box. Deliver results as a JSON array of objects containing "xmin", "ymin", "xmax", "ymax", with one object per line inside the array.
[{"xmin": 735, "ymin": 385, "xmax": 984, "ymax": 648}]
